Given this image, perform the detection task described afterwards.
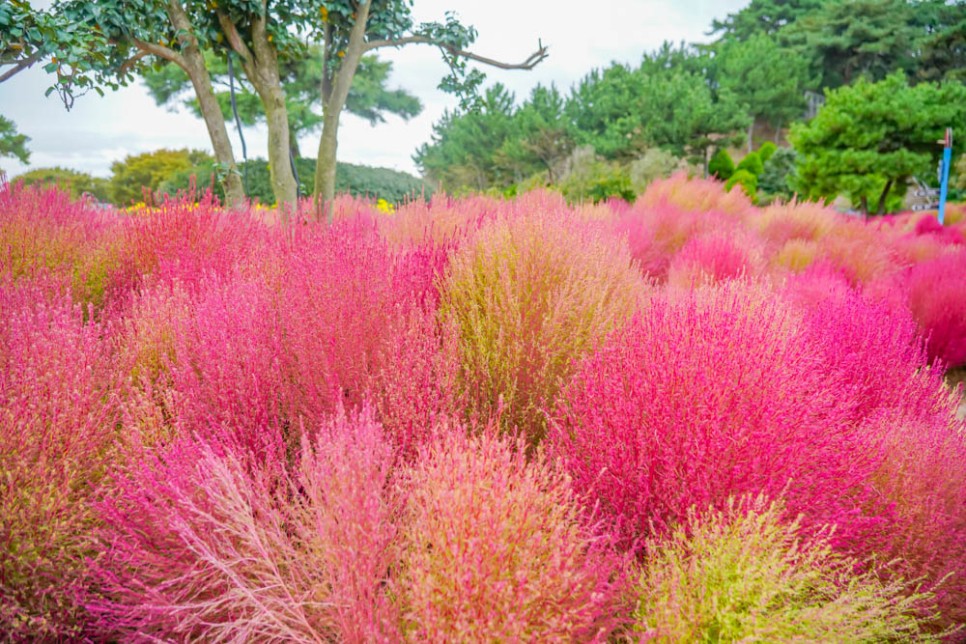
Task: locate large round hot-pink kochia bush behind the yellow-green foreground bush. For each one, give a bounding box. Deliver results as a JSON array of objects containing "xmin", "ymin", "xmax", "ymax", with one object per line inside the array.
[{"xmin": 551, "ymin": 284, "xmax": 885, "ymax": 545}]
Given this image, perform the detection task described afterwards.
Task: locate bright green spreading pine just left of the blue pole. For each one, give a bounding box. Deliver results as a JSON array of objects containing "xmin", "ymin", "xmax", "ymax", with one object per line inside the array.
[{"xmin": 790, "ymin": 73, "xmax": 966, "ymax": 214}]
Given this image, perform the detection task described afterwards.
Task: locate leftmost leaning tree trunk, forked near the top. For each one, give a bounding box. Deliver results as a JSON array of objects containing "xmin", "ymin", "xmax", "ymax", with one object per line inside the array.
[{"xmin": 159, "ymin": 0, "xmax": 245, "ymax": 208}]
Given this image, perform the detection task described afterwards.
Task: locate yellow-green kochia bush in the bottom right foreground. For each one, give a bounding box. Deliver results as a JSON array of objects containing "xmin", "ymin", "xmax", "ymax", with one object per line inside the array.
[{"xmin": 634, "ymin": 495, "xmax": 932, "ymax": 642}]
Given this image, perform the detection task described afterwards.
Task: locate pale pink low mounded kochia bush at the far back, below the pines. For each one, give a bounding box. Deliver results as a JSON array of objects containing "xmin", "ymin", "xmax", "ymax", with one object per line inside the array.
[{"xmin": 634, "ymin": 172, "xmax": 752, "ymax": 219}]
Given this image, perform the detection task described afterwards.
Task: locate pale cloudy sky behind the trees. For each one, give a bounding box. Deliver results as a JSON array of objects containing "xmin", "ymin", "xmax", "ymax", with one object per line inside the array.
[{"xmin": 0, "ymin": 0, "xmax": 748, "ymax": 177}]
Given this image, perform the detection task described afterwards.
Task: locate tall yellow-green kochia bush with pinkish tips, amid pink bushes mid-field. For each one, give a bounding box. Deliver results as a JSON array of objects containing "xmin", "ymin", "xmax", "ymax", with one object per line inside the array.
[{"xmin": 441, "ymin": 203, "xmax": 645, "ymax": 445}]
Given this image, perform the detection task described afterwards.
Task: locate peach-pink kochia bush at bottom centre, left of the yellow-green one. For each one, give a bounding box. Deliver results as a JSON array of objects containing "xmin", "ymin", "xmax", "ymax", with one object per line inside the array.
[{"xmin": 398, "ymin": 428, "xmax": 622, "ymax": 642}]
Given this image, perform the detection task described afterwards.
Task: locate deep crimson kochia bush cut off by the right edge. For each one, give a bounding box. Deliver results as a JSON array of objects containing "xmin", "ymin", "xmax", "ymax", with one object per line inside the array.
[{"xmin": 905, "ymin": 246, "xmax": 966, "ymax": 367}]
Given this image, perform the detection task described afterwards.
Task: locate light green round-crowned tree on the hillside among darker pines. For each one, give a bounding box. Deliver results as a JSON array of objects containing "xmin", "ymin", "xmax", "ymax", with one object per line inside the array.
[{"xmin": 717, "ymin": 34, "xmax": 812, "ymax": 152}]
